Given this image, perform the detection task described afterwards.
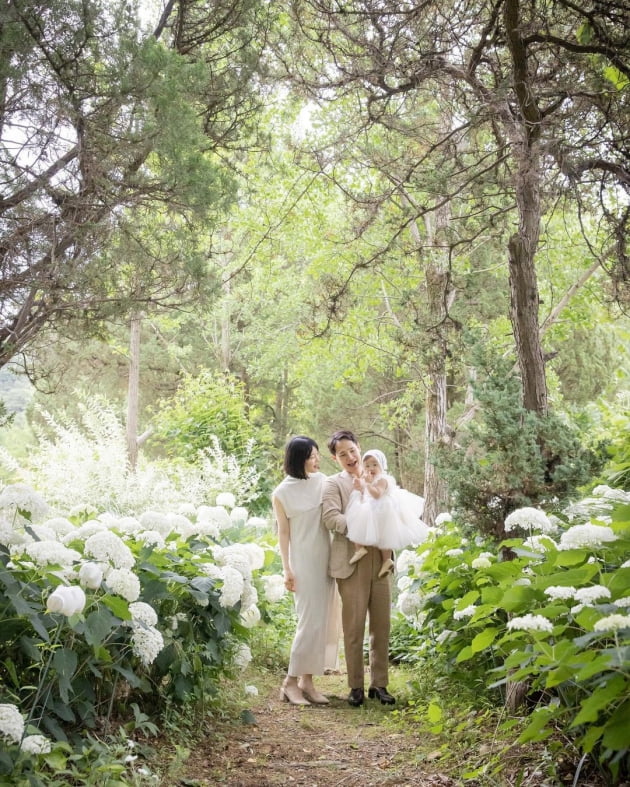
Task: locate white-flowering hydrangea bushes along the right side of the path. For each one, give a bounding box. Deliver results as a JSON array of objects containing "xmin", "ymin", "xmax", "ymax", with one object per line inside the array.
[{"xmin": 399, "ymin": 487, "xmax": 630, "ymax": 779}]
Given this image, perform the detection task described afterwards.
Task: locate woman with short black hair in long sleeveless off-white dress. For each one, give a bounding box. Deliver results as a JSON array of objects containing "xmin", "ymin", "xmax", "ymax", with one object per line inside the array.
[{"xmin": 271, "ymin": 436, "xmax": 339, "ymax": 705}]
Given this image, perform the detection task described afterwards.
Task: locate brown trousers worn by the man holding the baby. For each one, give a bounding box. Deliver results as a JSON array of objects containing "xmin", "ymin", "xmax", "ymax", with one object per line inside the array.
[{"xmin": 337, "ymin": 547, "xmax": 392, "ymax": 689}]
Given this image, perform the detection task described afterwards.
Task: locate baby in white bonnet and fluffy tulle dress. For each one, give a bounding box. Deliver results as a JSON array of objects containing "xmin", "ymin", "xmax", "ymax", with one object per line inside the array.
[{"xmin": 346, "ymin": 449, "xmax": 428, "ymax": 577}]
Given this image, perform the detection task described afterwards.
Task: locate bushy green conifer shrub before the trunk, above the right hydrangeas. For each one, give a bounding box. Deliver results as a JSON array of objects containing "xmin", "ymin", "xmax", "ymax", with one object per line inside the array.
[{"xmin": 435, "ymin": 346, "xmax": 602, "ymax": 537}]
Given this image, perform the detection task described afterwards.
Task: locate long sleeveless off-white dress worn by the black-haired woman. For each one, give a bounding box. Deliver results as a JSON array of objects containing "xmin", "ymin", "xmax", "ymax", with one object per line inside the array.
[{"xmin": 272, "ymin": 473, "xmax": 340, "ymax": 676}]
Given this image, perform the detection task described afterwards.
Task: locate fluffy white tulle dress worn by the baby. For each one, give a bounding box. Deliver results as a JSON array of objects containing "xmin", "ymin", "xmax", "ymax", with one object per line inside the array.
[{"xmin": 346, "ymin": 473, "xmax": 428, "ymax": 549}]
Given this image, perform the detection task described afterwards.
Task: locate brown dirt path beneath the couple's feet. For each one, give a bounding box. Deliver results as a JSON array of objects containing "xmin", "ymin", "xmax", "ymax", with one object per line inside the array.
[{"xmin": 176, "ymin": 675, "xmax": 456, "ymax": 787}]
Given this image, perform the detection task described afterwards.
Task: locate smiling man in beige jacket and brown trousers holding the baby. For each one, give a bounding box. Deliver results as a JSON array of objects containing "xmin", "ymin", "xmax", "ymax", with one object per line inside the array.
[{"xmin": 322, "ymin": 429, "xmax": 396, "ymax": 707}]
